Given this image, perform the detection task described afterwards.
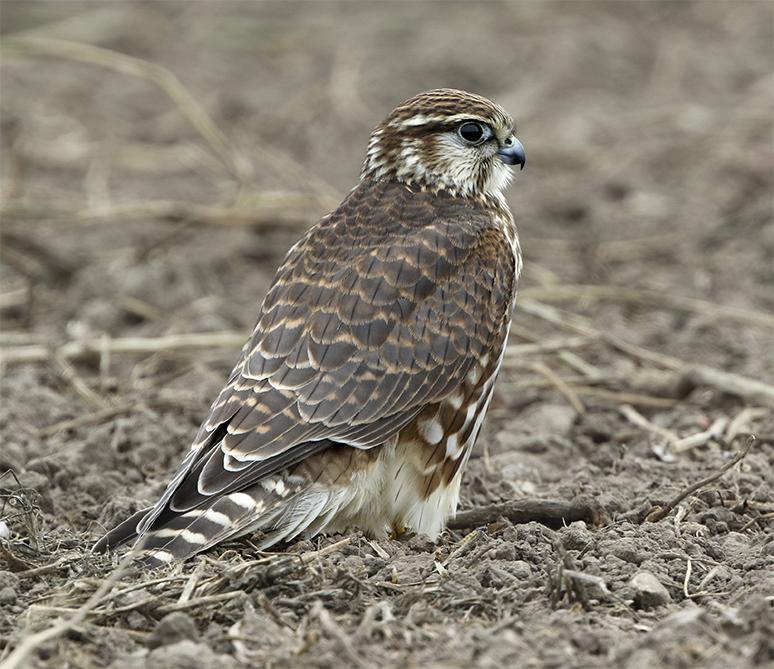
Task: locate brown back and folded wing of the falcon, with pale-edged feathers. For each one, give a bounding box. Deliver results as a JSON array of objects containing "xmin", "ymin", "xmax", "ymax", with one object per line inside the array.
[{"xmin": 139, "ymin": 182, "xmax": 514, "ymax": 536}]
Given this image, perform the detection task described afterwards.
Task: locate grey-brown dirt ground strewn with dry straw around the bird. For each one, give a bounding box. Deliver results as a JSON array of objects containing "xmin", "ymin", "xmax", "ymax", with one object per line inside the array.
[{"xmin": 0, "ymin": 0, "xmax": 774, "ymax": 669}]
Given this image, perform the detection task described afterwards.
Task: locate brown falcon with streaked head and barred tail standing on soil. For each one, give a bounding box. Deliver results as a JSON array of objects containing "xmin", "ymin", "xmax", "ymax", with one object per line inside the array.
[{"xmin": 94, "ymin": 88, "xmax": 526, "ymax": 567}]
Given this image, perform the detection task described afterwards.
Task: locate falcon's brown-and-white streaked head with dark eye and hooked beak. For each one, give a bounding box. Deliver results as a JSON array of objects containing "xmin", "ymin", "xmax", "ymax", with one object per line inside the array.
[{"xmin": 360, "ymin": 88, "xmax": 525, "ymax": 197}]
